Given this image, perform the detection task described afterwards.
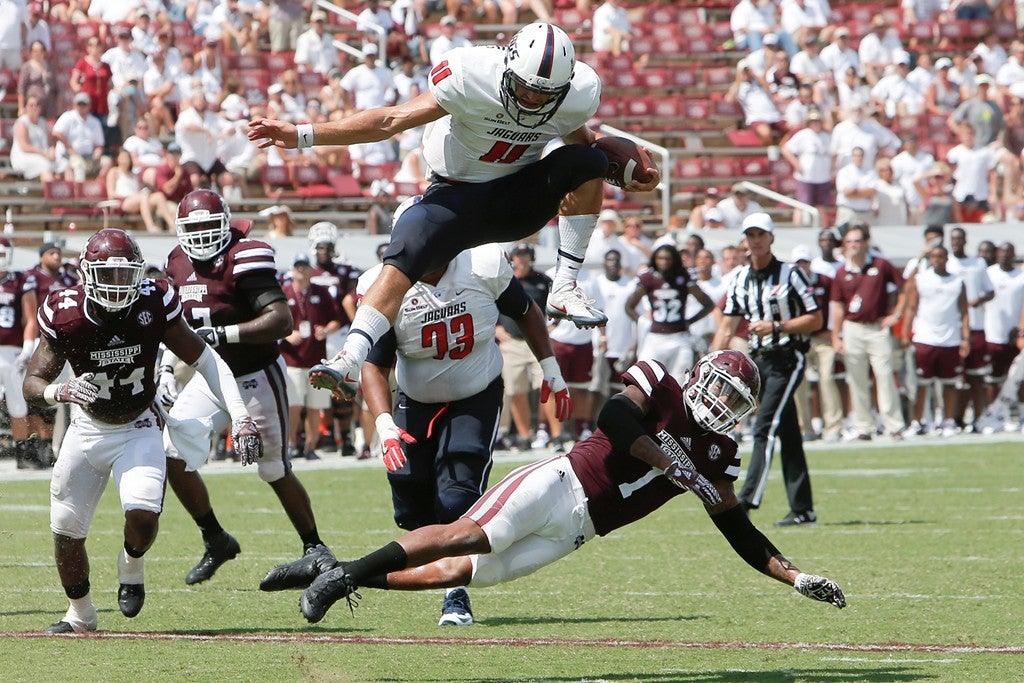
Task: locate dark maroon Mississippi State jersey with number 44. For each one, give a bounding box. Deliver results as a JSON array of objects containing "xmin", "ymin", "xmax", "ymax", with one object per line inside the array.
[{"xmin": 36, "ymin": 280, "xmax": 181, "ymax": 424}]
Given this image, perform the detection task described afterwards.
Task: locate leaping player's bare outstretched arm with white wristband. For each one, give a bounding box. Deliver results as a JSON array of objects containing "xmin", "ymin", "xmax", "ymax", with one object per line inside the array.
[{"xmin": 249, "ymin": 92, "xmax": 447, "ymax": 150}]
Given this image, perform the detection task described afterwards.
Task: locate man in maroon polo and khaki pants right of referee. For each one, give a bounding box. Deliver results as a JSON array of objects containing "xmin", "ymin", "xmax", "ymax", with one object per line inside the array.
[{"xmin": 830, "ymin": 227, "xmax": 905, "ymax": 441}]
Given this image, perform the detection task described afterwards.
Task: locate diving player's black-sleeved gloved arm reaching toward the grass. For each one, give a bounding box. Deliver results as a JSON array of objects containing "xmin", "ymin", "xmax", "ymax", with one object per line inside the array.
[{"xmin": 708, "ymin": 481, "xmax": 846, "ymax": 609}]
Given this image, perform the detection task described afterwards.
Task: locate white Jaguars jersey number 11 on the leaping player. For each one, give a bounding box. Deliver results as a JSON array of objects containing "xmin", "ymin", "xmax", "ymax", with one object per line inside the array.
[{"xmin": 423, "ymin": 46, "xmax": 601, "ymax": 182}]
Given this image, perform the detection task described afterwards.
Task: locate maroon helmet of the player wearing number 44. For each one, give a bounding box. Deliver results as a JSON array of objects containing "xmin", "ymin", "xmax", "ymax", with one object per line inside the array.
[{"xmin": 79, "ymin": 227, "xmax": 145, "ymax": 311}]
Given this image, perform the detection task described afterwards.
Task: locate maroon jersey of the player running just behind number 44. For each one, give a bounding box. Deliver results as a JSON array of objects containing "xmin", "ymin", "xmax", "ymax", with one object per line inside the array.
[{"xmin": 166, "ymin": 228, "xmax": 279, "ymax": 377}]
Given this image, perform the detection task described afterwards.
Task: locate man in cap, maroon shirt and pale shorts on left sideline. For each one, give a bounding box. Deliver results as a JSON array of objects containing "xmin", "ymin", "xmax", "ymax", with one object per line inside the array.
[{"xmin": 281, "ymin": 254, "xmax": 341, "ymax": 460}]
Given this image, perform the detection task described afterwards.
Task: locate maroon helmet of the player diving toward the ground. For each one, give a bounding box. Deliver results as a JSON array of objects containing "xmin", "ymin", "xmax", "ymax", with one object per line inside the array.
[{"xmin": 683, "ymin": 350, "xmax": 761, "ymax": 434}]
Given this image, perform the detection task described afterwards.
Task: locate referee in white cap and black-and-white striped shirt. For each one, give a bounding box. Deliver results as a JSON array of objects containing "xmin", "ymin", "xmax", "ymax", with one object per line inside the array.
[{"xmin": 714, "ymin": 213, "xmax": 821, "ymax": 526}]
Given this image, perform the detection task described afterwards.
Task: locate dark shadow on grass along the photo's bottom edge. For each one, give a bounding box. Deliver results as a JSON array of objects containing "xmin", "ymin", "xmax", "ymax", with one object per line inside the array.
[{"xmin": 381, "ymin": 667, "xmax": 936, "ymax": 683}]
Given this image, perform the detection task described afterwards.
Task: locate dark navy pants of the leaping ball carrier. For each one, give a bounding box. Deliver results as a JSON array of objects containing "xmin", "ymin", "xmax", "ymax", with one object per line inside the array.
[{"xmin": 384, "ymin": 144, "xmax": 608, "ymax": 283}]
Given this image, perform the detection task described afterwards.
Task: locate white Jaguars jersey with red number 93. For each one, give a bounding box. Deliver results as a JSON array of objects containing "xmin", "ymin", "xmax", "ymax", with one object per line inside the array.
[{"xmin": 356, "ymin": 244, "xmax": 512, "ymax": 403}]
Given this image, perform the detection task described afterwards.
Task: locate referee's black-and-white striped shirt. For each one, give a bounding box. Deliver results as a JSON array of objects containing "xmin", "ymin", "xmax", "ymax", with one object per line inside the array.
[{"xmin": 722, "ymin": 256, "xmax": 818, "ymax": 352}]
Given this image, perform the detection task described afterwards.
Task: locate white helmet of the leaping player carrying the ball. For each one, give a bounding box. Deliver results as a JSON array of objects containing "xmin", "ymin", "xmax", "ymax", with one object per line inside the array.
[{"xmin": 501, "ymin": 22, "xmax": 575, "ymax": 128}]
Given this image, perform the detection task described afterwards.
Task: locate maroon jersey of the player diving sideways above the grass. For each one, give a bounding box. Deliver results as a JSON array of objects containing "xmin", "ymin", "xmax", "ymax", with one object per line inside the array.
[{"xmin": 568, "ymin": 360, "xmax": 739, "ymax": 536}]
